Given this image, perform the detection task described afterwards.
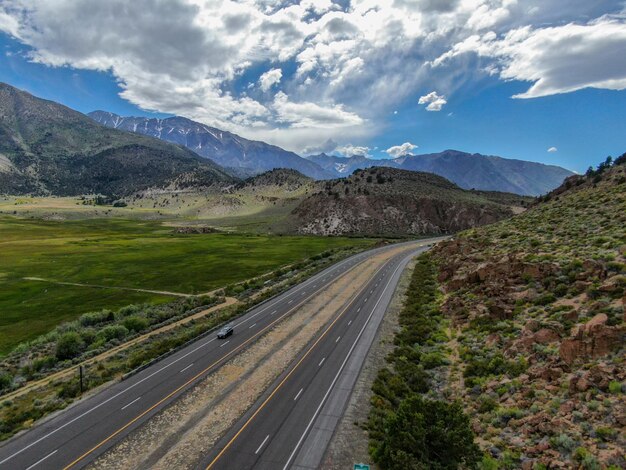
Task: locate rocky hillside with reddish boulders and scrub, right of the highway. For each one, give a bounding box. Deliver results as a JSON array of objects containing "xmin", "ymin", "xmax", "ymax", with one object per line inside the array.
[{"xmin": 432, "ymin": 155, "xmax": 626, "ymax": 469}]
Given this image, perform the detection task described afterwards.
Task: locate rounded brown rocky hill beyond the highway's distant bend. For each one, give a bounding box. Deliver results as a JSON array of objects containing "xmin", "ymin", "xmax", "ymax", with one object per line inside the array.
[{"xmin": 293, "ymin": 168, "xmax": 530, "ymax": 236}]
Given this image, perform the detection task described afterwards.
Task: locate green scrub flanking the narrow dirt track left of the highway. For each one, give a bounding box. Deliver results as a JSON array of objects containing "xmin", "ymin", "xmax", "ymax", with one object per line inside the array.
[{"xmin": 0, "ymin": 247, "xmax": 362, "ymax": 441}]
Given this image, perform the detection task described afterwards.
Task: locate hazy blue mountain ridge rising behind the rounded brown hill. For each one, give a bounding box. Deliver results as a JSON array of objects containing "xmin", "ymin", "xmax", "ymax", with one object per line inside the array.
[{"xmin": 307, "ymin": 150, "xmax": 574, "ymax": 196}]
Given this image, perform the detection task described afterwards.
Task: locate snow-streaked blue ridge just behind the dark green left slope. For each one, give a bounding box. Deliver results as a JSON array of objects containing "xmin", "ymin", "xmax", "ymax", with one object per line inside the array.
[{"xmin": 88, "ymin": 111, "xmax": 333, "ymax": 179}]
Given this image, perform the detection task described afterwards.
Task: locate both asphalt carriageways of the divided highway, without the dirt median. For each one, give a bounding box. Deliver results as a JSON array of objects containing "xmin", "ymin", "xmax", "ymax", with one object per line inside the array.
[{"xmin": 0, "ymin": 241, "xmax": 427, "ymax": 470}]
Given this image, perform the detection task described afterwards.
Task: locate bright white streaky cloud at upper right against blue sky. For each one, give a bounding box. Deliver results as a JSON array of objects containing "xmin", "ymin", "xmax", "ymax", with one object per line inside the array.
[{"xmin": 432, "ymin": 15, "xmax": 626, "ymax": 98}]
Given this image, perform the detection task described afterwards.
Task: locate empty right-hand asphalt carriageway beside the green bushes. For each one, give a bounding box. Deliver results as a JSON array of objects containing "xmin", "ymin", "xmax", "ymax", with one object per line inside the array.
[{"xmin": 198, "ymin": 248, "xmax": 426, "ymax": 470}]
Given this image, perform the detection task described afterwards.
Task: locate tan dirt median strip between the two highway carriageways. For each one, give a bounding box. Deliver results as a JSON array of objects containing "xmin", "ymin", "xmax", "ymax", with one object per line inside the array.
[{"xmin": 91, "ymin": 244, "xmax": 414, "ymax": 469}]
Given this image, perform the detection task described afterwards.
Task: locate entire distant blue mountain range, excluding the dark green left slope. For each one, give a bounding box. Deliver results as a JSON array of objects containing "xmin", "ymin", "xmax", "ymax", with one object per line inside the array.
[{"xmin": 89, "ymin": 111, "xmax": 573, "ymax": 196}]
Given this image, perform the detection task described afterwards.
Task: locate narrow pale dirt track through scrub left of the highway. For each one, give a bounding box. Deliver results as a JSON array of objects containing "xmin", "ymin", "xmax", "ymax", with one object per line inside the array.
[{"xmin": 2, "ymin": 297, "xmax": 238, "ymax": 401}]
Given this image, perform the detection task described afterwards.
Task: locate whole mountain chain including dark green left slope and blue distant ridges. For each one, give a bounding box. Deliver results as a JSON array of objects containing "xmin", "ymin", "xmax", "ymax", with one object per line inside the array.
[{"xmin": 0, "ymin": 84, "xmax": 572, "ymax": 196}]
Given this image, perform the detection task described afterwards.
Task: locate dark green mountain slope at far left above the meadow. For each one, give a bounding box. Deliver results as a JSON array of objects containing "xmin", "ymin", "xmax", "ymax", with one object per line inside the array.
[{"xmin": 0, "ymin": 83, "xmax": 232, "ymax": 196}]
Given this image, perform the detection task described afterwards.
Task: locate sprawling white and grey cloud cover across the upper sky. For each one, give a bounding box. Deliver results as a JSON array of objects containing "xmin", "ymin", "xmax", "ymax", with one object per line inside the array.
[{"xmin": 0, "ymin": 0, "xmax": 626, "ymax": 150}]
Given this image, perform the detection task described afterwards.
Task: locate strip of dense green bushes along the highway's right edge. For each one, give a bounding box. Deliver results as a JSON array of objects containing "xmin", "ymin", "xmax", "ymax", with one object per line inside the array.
[{"xmin": 367, "ymin": 255, "xmax": 480, "ymax": 470}]
